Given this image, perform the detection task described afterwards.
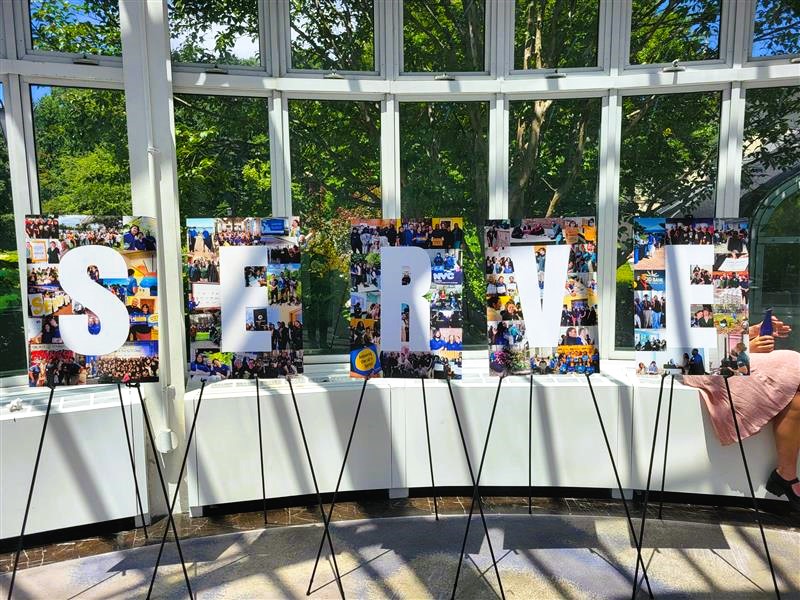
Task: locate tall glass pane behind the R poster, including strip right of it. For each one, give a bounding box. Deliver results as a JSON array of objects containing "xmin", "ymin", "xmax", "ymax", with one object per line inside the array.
[{"xmin": 400, "ymin": 102, "xmax": 489, "ymax": 349}]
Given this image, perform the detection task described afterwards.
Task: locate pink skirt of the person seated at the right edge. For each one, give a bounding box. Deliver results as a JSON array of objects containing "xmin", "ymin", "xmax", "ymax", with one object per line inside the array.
[{"xmin": 683, "ymin": 350, "xmax": 800, "ymax": 446}]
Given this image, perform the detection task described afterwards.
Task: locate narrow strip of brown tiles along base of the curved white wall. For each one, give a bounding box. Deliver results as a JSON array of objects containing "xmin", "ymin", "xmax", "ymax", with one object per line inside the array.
[{"xmin": 0, "ymin": 496, "xmax": 800, "ymax": 573}]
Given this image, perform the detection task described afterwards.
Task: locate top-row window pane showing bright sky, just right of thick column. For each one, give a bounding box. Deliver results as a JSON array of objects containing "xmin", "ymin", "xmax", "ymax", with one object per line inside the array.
[{"xmin": 167, "ymin": 0, "xmax": 261, "ymax": 66}]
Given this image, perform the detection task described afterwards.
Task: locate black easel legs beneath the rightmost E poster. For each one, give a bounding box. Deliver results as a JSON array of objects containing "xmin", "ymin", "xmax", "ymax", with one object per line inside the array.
[{"xmin": 631, "ymin": 373, "xmax": 781, "ymax": 600}]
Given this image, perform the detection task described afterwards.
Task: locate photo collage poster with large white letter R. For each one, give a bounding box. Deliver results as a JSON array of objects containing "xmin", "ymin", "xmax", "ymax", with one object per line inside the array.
[{"xmin": 349, "ymin": 217, "xmax": 464, "ymax": 379}]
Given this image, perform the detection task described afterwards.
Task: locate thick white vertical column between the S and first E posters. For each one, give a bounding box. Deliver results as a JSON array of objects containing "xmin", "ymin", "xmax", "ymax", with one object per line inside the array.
[{"xmin": 120, "ymin": 0, "xmax": 186, "ymax": 508}]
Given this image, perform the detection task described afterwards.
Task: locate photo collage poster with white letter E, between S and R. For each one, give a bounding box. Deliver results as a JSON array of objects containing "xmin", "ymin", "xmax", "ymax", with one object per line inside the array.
[{"xmin": 184, "ymin": 217, "xmax": 303, "ymax": 383}]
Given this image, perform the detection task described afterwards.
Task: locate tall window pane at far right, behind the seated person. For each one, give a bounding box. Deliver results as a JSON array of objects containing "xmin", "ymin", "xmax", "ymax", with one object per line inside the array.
[{"xmin": 739, "ymin": 87, "xmax": 800, "ymax": 349}]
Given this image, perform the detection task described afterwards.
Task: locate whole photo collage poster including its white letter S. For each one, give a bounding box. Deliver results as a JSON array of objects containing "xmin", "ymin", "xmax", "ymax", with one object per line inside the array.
[{"xmin": 25, "ymin": 215, "xmax": 158, "ymax": 387}]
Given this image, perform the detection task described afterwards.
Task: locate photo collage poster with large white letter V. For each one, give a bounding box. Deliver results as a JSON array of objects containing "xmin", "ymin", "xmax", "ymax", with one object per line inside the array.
[{"xmin": 484, "ymin": 217, "xmax": 600, "ymax": 376}]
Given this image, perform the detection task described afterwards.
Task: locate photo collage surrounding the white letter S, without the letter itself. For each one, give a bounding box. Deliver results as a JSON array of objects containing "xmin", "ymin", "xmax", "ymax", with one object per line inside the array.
[{"xmin": 25, "ymin": 215, "xmax": 158, "ymax": 387}]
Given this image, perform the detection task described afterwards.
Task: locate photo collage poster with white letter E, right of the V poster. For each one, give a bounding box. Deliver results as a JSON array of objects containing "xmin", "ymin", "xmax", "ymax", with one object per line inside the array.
[{"xmin": 633, "ymin": 217, "xmax": 750, "ymax": 375}]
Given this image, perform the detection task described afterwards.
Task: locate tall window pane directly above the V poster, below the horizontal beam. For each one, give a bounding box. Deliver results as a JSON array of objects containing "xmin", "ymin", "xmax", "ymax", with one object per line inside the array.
[{"xmin": 508, "ymin": 98, "xmax": 602, "ymax": 219}]
